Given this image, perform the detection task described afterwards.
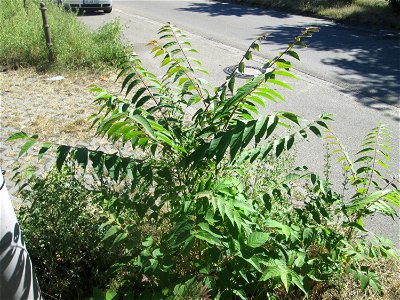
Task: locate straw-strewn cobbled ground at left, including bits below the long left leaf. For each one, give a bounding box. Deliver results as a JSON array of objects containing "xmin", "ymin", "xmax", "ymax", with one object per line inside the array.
[{"xmin": 0, "ymin": 69, "xmax": 120, "ymax": 197}]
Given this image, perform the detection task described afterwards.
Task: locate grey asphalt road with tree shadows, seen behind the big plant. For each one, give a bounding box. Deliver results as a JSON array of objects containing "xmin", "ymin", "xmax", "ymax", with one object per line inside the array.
[{"xmin": 80, "ymin": 0, "xmax": 400, "ymax": 247}]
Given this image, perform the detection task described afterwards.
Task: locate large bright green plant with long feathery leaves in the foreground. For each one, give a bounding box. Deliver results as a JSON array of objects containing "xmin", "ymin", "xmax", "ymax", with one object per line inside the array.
[{"xmin": 9, "ymin": 24, "xmax": 400, "ymax": 299}]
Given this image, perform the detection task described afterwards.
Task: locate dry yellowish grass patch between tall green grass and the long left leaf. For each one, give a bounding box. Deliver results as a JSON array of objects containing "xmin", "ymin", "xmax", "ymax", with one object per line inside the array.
[{"xmin": 0, "ymin": 69, "xmax": 118, "ymax": 143}]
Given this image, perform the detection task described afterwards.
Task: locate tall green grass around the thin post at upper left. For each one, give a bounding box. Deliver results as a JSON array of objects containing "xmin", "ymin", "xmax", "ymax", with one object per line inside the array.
[{"xmin": 0, "ymin": 0, "xmax": 126, "ymax": 70}]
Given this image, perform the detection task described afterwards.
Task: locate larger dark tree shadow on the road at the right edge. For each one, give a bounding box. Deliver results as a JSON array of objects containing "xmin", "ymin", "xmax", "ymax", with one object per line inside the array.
[{"xmin": 258, "ymin": 24, "xmax": 400, "ymax": 120}]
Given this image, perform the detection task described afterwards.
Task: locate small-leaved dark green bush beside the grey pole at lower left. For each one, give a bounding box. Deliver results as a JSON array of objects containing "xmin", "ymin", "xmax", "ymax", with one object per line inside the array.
[{"xmin": 19, "ymin": 167, "xmax": 116, "ymax": 299}]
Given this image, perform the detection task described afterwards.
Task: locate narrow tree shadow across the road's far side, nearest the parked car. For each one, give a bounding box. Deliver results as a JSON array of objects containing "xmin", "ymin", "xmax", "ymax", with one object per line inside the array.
[{"xmin": 178, "ymin": 1, "xmax": 291, "ymax": 19}]
